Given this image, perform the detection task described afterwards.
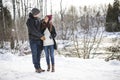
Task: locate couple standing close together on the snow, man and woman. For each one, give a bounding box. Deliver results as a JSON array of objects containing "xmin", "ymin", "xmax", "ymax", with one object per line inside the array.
[{"xmin": 26, "ymin": 8, "xmax": 57, "ymax": 73}]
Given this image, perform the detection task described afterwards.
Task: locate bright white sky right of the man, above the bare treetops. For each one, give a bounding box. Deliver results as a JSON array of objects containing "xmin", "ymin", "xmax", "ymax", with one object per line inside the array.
[{"xmin": 47, "ymin": 0, "xmax": 114, "ymax": 14}]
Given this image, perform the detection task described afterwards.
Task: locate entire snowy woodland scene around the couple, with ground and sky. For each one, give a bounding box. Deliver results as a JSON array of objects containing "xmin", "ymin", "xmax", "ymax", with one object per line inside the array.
[{"xmin": 0, "ymin": 0, "xmax": 120, "ymax": 80}]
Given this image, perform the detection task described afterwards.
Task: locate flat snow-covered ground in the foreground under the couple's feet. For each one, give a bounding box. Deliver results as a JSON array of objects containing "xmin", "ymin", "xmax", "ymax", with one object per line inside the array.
[{"xmin": 0, "ymin": 52, "xmax": 120, "ymax": 80}]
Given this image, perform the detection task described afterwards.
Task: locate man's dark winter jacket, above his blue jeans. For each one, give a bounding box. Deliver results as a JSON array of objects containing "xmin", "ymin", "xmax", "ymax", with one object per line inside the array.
[{"xmin": 26, "ymin": 13, "xmax": 43, "ymax": 41}]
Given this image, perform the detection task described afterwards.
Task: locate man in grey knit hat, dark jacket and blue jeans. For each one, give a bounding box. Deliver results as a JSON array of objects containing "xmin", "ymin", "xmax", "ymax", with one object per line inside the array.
[{"xmin": 26, "ymin": 8, "xmax": 45, "ymax": 73}]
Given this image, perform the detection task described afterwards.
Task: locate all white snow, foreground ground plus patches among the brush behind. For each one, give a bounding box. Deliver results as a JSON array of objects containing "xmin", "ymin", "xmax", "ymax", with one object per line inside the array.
[{"xmin": 0, "ymin": 28, "xmax": 120, "ymax": 80}]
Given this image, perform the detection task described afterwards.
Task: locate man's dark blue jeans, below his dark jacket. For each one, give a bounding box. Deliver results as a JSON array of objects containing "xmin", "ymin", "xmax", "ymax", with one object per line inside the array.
[{"xmin": 30, "ymin": 40, "xmax": 43, "ymax": 69}]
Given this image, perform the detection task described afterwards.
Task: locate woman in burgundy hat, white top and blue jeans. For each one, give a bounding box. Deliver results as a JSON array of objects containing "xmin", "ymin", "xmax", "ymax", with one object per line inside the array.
[{"xmin": 42, "ymin": 15, "xmax": 56, "ymax": 72}]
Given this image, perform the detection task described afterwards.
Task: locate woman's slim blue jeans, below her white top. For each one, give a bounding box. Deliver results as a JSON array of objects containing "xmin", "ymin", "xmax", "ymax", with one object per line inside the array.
[{"xmin": 44, "ymin": 45, "xmax": 55, "ymax": 65}]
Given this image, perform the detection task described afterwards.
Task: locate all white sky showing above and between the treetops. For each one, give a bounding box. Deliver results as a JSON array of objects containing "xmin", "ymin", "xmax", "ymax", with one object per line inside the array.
[{"xmin": 3, "ymin": 0, "xmax": 114, "ymax": 14}]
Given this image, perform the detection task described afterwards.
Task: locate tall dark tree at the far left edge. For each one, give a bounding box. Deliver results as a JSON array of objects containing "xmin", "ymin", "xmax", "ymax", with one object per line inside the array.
[{"xmin": 0, "ymin": 0, "xmax": 12, "ymax": 48}]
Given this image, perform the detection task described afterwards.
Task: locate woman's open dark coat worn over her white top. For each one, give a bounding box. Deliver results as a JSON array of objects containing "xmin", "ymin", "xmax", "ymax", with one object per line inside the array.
[{"xmin": 41, "ymin": 20, "xmax": 57, "ymax": 50}]
